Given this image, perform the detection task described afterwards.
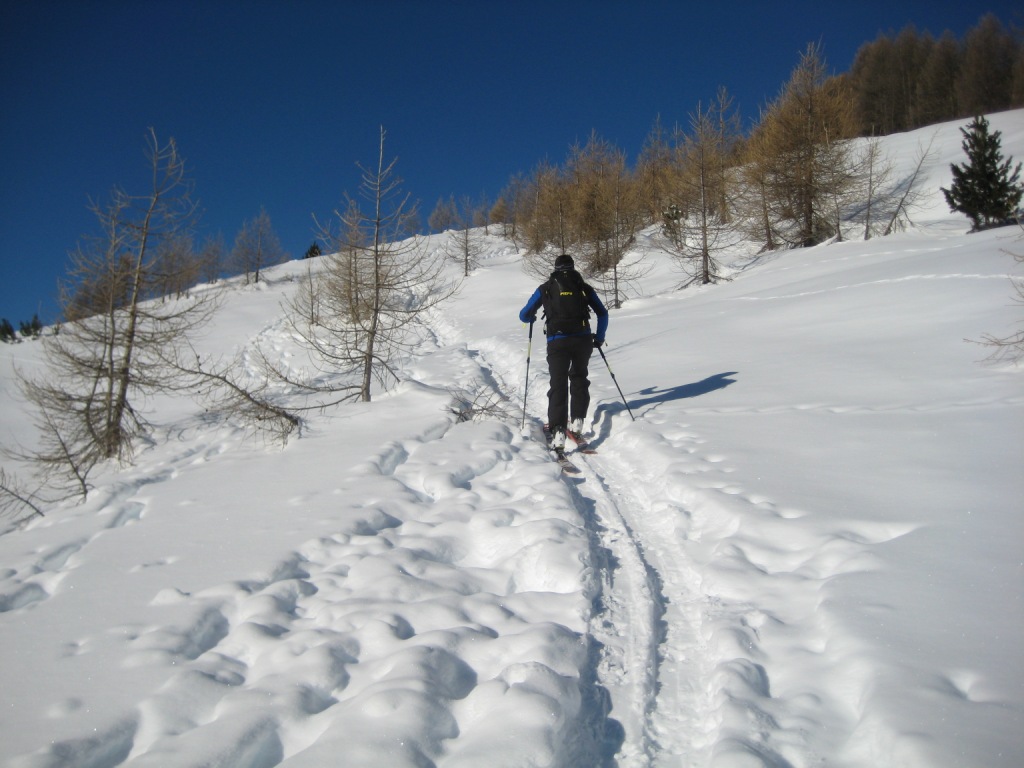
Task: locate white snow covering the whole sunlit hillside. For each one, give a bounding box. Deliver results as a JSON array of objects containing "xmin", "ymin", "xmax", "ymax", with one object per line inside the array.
[{"xmin": 6, "ymin": 111, "xmax": 1024, "ymax": 768}]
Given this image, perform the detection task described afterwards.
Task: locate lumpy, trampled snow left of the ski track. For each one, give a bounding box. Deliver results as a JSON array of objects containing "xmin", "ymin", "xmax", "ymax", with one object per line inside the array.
[{"xmin": 4, "ymin": 403, "xmax": 605, "ymax": 766}]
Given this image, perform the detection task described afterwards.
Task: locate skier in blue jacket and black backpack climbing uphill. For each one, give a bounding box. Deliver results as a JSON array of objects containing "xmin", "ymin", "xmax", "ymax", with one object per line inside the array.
[{"xmin": 519, "ymin": 253, "xmax": 608, "ymax": 454}]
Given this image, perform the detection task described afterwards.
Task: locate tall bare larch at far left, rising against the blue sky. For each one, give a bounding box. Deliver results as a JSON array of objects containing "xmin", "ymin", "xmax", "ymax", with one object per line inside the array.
[{"xmin": 9, "ymin": 130, "xmax": 216, "ymax": 496}]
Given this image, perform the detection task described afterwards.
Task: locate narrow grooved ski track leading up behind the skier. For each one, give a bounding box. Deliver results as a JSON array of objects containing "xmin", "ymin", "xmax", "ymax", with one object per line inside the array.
[{"xmin": 435, "ymin": 318, "xmax": 699, "ymax": 768}]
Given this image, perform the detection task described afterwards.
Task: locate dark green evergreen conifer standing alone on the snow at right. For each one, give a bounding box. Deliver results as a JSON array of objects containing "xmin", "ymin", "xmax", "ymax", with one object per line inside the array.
[{"xmin": 942, "ymin": 117, "xmax": 1024, "ymax": 231}]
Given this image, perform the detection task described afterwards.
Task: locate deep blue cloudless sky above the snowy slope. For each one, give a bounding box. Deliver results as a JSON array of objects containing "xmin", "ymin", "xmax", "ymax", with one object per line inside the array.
[{"xmin": 0, "ymin": 0, "xmax": 1021, "ymax": 327}]
